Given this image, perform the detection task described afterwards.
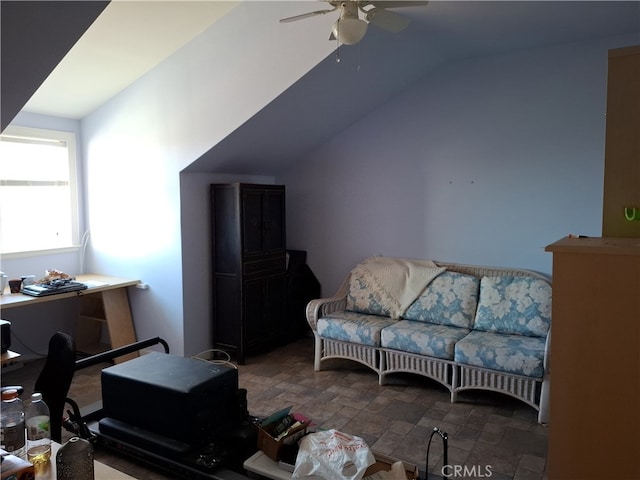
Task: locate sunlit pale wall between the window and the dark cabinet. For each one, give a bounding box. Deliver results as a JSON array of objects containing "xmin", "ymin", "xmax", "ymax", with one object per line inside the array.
[{"xmin": 82, "ymin": 2, "xmax": 331, "ymax": 354}]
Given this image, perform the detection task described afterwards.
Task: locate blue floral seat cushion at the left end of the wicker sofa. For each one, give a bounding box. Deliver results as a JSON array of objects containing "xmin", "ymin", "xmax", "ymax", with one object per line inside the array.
[{"xmin": 317, "ymin": 311, "xmax": 395, "ymax": 347}]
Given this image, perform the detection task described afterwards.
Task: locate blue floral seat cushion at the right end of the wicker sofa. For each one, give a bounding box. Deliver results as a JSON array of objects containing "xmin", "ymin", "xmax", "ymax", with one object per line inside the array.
[{"xmin": 454, "ymin": 330, "xmax": 545, "ymax": 378}]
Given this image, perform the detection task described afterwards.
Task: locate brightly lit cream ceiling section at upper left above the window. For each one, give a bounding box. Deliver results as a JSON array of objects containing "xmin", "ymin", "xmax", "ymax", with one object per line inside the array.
[{"xmin": 24, "ymin": 0, "xmax": 238, "ymax": 118}]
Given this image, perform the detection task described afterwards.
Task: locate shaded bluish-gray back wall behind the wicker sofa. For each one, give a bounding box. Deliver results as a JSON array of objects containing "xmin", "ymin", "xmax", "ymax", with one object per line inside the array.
[{"xmin": 276, "ymin": 36, "xmax": 637, "ymax": 295}]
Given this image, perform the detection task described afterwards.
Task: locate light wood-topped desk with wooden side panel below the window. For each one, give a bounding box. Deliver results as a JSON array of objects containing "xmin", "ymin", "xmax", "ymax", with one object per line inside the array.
[{"xmin": 0, "ymin": 274, "xmax": 139, "ymax": 362}]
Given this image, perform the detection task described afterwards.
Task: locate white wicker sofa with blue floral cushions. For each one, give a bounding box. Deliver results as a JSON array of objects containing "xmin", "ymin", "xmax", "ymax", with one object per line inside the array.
[{"xmin": 306, "ymin": 257, "xmax": 551, "ymax": 423}]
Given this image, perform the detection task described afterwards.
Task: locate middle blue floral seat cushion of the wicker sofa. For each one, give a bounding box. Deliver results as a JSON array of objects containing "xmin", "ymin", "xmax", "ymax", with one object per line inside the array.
[{"xmin": 381, "ymin": 320, "xmax": 469, "ymax": 360}]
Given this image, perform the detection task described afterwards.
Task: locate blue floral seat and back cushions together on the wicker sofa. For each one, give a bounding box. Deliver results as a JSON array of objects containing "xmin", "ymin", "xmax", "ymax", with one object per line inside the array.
[{"xmin": 317, "ymin": 271, "xmax": 551, "ymax": 378}]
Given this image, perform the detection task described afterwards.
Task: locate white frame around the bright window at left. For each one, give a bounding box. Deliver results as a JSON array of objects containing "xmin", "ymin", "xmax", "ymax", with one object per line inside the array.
[{"xmin": 0, "ymin": 125, "xmax": 80, "ymax": 258}]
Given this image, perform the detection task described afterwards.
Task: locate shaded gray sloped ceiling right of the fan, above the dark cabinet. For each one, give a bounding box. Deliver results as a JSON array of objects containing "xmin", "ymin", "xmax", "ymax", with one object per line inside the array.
[{"xmin": 181, "ymin": 1, "xmax": 640, "ymax": 174}]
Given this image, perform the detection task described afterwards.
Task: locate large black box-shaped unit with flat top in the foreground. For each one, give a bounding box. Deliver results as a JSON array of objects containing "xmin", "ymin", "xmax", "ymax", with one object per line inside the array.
[{"xmin": 96, "ymin": 352, "xmax": 256, "ymax": 479}]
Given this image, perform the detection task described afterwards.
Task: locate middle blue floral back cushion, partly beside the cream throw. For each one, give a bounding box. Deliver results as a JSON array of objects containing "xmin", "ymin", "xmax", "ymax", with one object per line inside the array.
[{"xmin": 404, "ymin": 272, "xmax": 480, "ymax": 328}]
